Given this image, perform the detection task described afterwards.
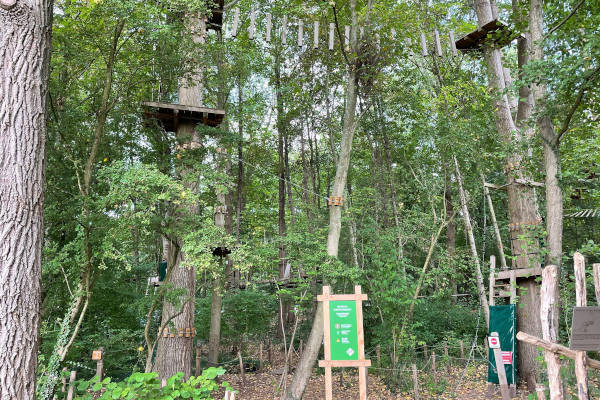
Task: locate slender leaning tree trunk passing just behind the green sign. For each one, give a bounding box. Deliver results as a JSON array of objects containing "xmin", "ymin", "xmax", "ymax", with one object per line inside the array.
[{"xmin": 285, "ymin": 7, "xmax": 358, "ymax": 400}]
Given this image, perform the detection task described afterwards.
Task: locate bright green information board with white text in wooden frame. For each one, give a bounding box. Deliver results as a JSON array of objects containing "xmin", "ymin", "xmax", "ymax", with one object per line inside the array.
[{"xmin": 329, "ymin": 301, "xmax": 358, "ymax": 360}]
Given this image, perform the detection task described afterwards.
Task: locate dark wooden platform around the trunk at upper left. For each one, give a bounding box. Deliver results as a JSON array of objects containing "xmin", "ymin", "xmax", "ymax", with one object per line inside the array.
[{"xmin": 142, "ymin": 101, "xmax": 225, "ymax": 132}]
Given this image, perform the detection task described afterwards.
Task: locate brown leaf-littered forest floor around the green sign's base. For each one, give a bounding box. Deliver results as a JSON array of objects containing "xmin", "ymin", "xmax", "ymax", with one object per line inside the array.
[{"xmin": 215, "ymin": 348, "xmax": 527, "ymax": 400}]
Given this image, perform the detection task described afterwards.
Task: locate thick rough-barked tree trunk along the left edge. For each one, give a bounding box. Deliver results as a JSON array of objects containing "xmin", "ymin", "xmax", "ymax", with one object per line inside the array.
[{"xmin": 0, "ymin": 0, "xmax": 52, "ymax": 400}]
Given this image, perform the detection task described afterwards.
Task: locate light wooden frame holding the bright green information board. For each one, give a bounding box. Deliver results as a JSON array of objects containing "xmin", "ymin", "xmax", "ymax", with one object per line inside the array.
[{"xmin": 317, "ymin": 285, "xmax": 371, "ymax": 400}]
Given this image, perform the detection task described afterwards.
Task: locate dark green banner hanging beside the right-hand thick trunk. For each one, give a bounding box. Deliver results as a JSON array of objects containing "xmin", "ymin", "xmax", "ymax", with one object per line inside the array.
[{"xmin": 488, "ymin": 304, "xmax": 517, "ymax": 385}]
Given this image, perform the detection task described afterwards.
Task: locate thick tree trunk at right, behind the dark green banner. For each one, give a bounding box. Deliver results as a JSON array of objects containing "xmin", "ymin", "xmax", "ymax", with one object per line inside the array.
[{"xmin": 475, "ymin": 0, "xmax": 541, "ymax": 390}]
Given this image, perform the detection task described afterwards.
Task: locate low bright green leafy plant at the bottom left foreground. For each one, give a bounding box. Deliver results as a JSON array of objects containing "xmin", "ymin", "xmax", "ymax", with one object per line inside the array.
[{"xmin": 68, "ymin": 368, "xmax": 231, "ymax": 400}]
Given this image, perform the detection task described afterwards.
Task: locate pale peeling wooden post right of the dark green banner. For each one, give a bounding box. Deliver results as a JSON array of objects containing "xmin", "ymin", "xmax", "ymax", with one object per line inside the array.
[{"xmin": 540, "ymin": 265, "xmax": 563, "ymax": 400}]
